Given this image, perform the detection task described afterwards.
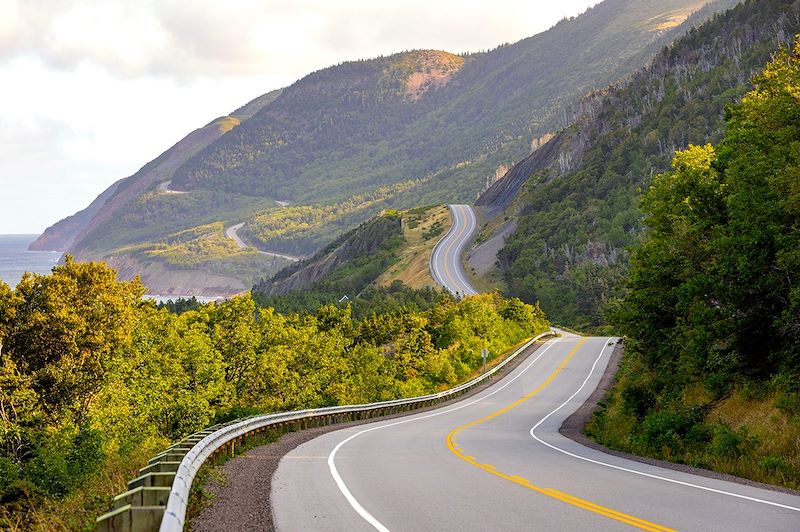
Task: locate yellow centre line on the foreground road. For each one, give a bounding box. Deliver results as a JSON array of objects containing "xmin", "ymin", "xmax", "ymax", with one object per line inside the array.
[{"xmin": 446, "ymin": 338, "xmax": 672, "ymax": 532}]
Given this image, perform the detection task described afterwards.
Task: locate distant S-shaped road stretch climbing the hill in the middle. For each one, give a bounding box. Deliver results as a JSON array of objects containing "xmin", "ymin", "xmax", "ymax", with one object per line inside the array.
[{"xmin": 430, "ymin": 205, "xmax": 478, "ymax": 296}]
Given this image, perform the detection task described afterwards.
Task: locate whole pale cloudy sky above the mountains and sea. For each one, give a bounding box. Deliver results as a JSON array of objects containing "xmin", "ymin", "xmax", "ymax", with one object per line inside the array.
[{"xmin": 0, "ymin": 0, "xmax": 598, "ymax": 234}]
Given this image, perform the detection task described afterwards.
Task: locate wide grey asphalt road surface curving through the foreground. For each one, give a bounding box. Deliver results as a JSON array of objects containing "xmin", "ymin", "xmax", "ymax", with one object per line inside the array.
[{"xmin": 271, "ymin": 337, "xmax": 800, "ymax": 531}]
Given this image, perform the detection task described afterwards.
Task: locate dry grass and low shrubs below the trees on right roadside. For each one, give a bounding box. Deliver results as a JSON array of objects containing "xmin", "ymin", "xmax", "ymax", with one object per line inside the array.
[{"xmin": 585, "ymin": 350, "xmax": 800, "ymax": 489}]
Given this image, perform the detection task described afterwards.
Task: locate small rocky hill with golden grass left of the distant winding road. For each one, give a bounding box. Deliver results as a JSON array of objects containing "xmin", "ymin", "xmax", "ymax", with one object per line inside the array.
[{"xmin": 252, "ymin": 205, "xmax": 451, "ymax": 317}]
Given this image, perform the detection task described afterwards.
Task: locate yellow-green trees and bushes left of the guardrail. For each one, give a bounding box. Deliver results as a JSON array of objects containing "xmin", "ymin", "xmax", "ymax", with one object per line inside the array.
[{"xmin": 0, "ymin": 259, "xmax": 548, "ymax": 530}]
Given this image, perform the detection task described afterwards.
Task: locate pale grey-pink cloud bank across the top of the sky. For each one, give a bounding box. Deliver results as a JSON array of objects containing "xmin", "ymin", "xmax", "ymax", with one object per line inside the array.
[{"xmin": 0, "ymin": 0, "xmax": 596, "ymax": 79}]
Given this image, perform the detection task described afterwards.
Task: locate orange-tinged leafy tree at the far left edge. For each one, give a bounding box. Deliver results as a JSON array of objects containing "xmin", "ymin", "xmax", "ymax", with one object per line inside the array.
[{"xmin": 3, "ymin": 256, "xmax": 144, "ymax": 423}]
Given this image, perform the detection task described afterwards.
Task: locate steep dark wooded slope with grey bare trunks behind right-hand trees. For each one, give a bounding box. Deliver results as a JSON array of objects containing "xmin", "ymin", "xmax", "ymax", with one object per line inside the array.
[{"xmin": 498, "ymin": 0, "xmax": 800, "ymax": 330}]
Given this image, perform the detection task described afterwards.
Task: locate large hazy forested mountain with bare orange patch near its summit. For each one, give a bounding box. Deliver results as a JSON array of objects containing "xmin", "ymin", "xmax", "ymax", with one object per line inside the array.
[{"xmin": 36, "ymin": 0, "xmax": 731, "ymax": 296}]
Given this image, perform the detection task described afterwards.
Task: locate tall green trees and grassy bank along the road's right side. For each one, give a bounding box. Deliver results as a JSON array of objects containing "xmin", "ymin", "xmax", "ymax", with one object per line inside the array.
[{"xmin": 590, "ymin": 42, "xmax": 800, "ymax": 488}]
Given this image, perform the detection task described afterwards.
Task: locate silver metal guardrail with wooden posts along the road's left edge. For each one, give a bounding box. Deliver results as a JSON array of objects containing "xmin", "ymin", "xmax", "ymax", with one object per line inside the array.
[{"xmin": 97, "ymin": 330, "xmax": 556, "ymax": 532}]
